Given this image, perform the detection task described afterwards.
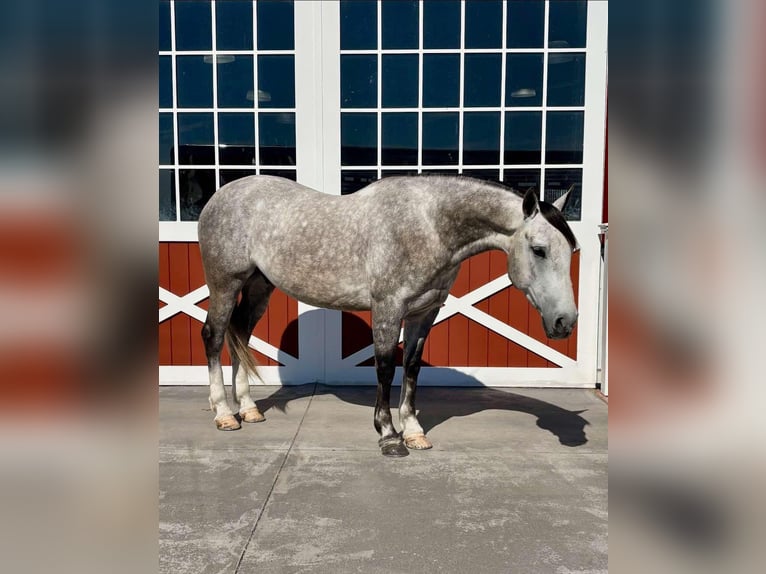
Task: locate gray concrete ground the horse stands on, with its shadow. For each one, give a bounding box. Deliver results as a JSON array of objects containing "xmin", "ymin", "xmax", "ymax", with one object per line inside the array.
[{"xmin": 159, "ymin": 384, "xmax": 607, "ymax": 574}]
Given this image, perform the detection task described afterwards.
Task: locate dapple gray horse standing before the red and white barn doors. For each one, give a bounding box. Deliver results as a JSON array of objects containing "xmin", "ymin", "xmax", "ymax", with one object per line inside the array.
[{"xmin": 198, "ymin": 176, "xmax": 577, "ymax": 456}]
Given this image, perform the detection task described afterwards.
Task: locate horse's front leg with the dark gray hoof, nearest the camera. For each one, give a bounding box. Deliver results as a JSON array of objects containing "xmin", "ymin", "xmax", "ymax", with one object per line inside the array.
[{"xmin": 372, "ymin": 305, "xmax": 409, "ymax": 456}]
